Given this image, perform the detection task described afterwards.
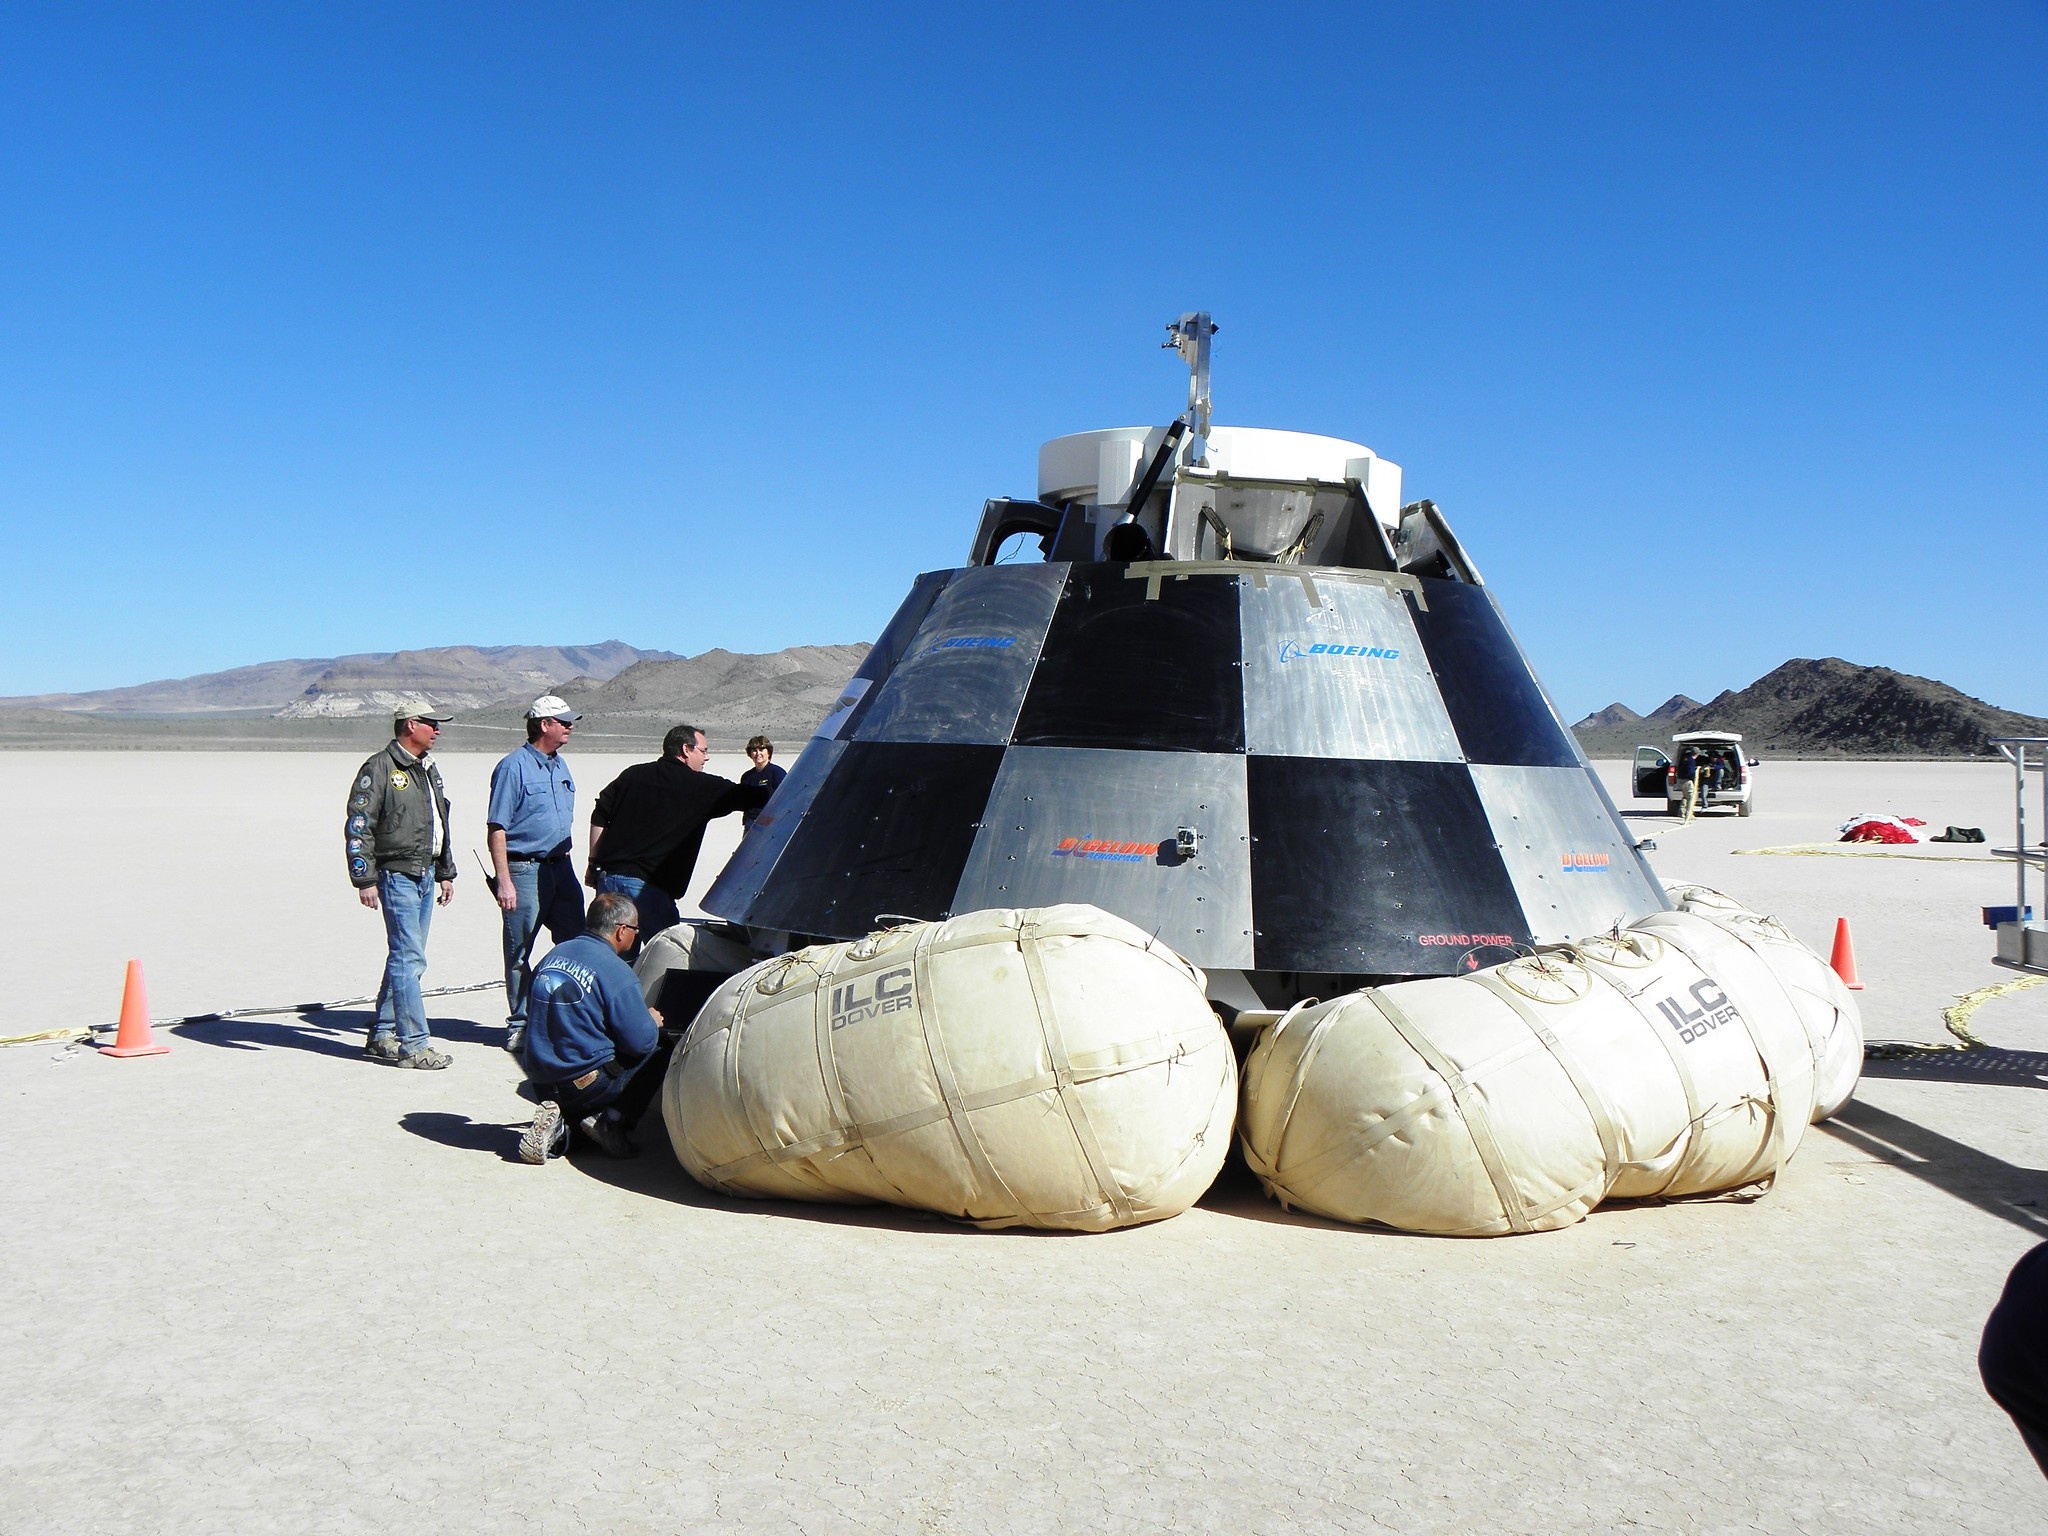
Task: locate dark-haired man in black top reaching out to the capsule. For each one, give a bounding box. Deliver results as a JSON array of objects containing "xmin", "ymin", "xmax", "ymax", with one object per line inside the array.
[{"xmin": 584, "ymin": 725, "xmax": 772, "ymax": 948}]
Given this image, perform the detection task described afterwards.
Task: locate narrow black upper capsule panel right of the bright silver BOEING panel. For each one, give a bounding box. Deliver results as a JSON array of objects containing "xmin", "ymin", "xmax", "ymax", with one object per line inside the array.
[{"xmin": 1415, "ymin": 582, "xmax": 1579, "ymax": 768}]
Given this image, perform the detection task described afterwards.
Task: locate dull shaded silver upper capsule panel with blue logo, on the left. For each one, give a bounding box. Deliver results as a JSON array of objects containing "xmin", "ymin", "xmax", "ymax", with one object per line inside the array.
[{"xmin": 854, "ymin": 563, "xmax": 1067, "ymax": 745}]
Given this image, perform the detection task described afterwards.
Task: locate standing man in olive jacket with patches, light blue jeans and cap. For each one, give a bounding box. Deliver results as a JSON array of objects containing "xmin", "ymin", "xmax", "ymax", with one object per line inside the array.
[{"xmin": 344, "ymin": 715, "xmax": 455, "ymax": 1071}]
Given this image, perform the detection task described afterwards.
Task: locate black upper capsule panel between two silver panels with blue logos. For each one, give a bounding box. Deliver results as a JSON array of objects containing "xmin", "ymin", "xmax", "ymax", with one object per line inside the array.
[{"xmin": 1012, "ymin": 563, "xmax": 1245, "ymax": 752}]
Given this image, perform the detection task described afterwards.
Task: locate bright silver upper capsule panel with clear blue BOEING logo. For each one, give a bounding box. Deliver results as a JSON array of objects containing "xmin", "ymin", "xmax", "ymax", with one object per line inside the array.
[{"xmin": 1239, "ymin": 571, "xmax": 1462, "ymax": 762}]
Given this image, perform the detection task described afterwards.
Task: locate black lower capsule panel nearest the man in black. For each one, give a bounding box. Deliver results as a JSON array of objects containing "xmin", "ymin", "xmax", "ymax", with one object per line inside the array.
[{"xmin": 748, "ymin": 741, "xmax": 1004, "ymax": 938}]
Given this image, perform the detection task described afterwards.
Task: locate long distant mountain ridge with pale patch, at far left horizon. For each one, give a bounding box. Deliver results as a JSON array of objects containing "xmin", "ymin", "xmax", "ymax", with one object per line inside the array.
[{"xmin": 0, "ymin": 641, "xmax": 676, "ymax": 719}]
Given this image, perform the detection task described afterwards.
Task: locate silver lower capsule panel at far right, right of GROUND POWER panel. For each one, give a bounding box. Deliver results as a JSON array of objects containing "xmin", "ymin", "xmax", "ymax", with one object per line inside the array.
[{"xmin": 1470, "ymin": 764, "xmax": 1667, "ymax": 944}]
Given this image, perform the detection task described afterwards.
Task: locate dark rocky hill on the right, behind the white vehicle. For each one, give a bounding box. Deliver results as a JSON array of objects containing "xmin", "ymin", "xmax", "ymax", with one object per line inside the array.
[{"xmin": 1573, "ymin": 655, "xmax": 2048, "ymax": 758}]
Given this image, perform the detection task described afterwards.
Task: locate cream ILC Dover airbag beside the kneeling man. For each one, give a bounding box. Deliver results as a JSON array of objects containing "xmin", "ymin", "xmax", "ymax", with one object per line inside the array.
[{"xmin": 662, "ymin": 905, "xmax": 1237, "ymax": 1231}]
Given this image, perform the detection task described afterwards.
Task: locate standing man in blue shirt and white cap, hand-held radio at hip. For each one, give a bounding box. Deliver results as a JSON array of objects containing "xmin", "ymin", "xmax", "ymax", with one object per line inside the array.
[{"xmin": 485, "ymin": 694, "xmax": 584, "ymax": 1053}]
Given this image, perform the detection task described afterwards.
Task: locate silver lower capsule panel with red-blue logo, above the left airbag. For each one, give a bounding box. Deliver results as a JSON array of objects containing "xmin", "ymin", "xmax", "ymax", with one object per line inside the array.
[{"xmin": 952, "ymin": 748, "xmax": 1251, "ymax": 969}]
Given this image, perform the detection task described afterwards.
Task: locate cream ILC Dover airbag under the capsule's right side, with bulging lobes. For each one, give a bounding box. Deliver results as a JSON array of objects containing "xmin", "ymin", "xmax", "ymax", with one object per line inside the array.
[{"xmin": 1239, "ymin": 887, "xmax": 1862, "ymax": 1237}]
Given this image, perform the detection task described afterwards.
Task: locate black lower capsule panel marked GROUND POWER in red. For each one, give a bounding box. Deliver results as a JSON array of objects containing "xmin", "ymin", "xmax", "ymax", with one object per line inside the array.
[{"xmin": 1245, "ymin": 757, "xmax": 1530, "ymax": 975}]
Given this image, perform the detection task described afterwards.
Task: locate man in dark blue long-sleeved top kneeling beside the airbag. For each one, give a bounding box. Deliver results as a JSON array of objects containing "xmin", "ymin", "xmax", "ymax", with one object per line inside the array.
[{"xmin": 518, "ymin": 891, "xmax": 674, "ymax": 1163}]
